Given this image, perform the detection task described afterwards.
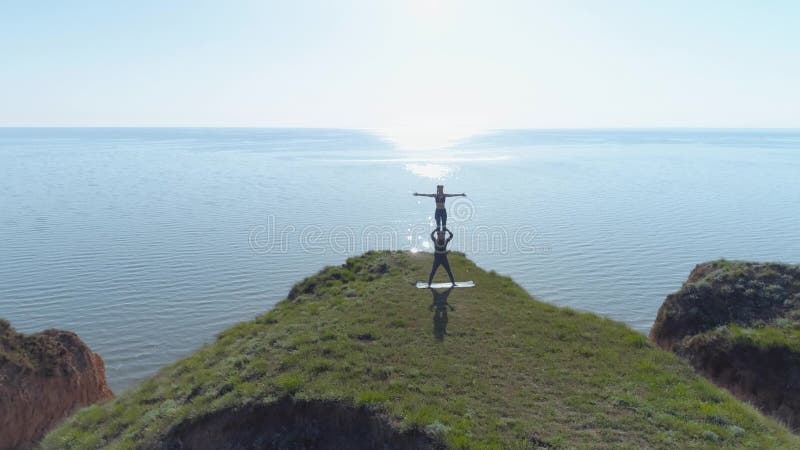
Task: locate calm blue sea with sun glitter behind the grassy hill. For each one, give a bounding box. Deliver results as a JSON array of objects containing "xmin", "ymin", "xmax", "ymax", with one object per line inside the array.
[{"xmin": 0, "ymin": 129, "xmax": 800, "ymax": 391}]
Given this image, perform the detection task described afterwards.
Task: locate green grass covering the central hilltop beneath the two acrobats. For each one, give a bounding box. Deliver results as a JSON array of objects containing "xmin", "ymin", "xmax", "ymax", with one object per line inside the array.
[{"xmin": 42, "ymin": 252, "xmax": 800, "ymax": 449}]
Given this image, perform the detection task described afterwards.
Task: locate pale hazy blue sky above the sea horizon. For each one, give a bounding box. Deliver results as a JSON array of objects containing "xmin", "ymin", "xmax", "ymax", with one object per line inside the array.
[{"xmin": 0, "ymin": 0, "xmax": 800, "ymax": 135}]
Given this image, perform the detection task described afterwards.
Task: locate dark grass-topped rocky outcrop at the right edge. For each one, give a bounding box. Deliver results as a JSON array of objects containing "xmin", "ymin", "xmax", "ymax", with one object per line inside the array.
[{"xmin": 650, "ymin": 260, "xmax": 800, "ymax": 430}]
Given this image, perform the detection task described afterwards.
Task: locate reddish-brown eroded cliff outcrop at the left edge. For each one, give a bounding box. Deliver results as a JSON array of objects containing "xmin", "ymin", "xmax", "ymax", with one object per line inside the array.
[{"xmin": 0, "ymin": 319, "xmax": 113, "ymax": 449}]
